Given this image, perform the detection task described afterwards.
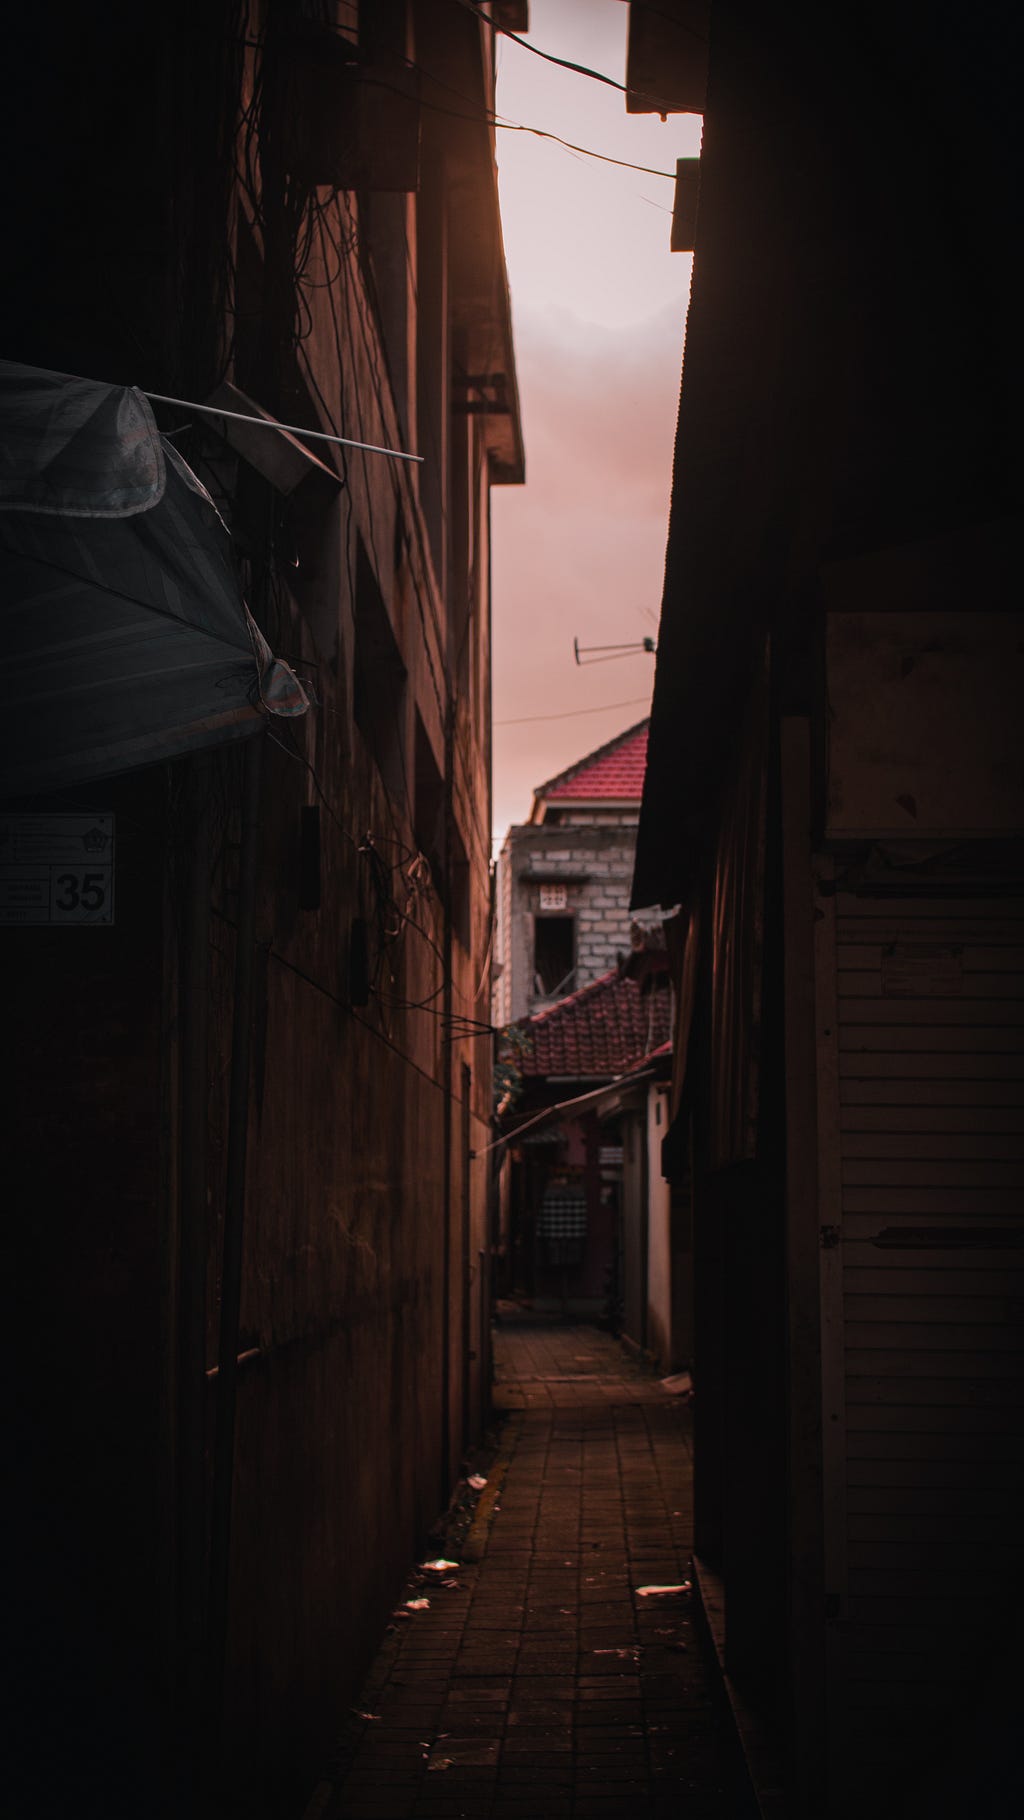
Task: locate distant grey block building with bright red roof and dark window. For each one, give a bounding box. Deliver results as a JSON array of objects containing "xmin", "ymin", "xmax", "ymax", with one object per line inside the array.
[{"xmin": 495, "ymin": 721, "xmax": 649, "ymax": 1025}]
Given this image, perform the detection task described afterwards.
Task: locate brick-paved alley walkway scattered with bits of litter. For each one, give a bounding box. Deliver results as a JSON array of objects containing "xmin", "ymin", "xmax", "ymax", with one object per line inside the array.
[{"xmin": 309, "ymin": 1310, "xmax": 748, "ymax": 1820}]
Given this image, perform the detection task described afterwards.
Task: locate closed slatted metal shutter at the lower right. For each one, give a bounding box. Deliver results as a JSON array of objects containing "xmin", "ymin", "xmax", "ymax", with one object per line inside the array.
[{"xmin": 818, "ymin": 894, "xmax": 1024, "ymax": 1813}]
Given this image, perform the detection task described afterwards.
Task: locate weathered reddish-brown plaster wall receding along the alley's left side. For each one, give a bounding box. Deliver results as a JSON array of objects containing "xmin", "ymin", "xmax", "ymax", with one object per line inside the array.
[{"xmin": 199, "ymin": 160, "xmax": 491, "ymax": 1798}]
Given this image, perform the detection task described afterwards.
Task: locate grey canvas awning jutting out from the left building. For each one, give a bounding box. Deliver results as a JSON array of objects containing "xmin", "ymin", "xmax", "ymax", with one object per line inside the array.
[{"xmin": 0, "ymin": 362, "xmax": 309, "ymax": 795}]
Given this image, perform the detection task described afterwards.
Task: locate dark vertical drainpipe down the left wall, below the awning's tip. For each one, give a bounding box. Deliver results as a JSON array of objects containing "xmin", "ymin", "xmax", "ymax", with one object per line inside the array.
[{"xmin": 207, "ymin": 732, "xmax": 264, "ymax": 1775}]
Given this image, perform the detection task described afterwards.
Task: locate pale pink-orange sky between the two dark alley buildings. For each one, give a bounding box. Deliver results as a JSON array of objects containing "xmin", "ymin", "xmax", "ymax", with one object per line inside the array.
[{"xmin": 491, "ymin": 0, "xmax": 700, "ymax": 835}]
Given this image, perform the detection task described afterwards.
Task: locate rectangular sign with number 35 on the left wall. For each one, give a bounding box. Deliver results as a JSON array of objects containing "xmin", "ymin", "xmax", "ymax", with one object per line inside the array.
[{"xmin": 0, "ymin": 814, "xmax": 115, "ymax": 926}]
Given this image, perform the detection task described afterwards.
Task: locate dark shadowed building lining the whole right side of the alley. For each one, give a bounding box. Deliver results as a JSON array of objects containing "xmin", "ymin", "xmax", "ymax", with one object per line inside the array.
[{"xmin": 633, "ymin": 4, "xmax": 1024, "ymax": 1820}]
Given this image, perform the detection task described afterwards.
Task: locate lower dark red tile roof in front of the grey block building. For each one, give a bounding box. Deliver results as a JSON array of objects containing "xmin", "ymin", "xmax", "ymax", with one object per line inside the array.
[{"xmin": 517, "ymin": 972, "xmax": 669, "ymax": 1077}]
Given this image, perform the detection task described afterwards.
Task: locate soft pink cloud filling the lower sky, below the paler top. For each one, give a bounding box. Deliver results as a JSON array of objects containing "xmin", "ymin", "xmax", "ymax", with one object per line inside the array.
[{"xmin": 491, "ymin": 300, "xmax": 686, "ymax": 828}]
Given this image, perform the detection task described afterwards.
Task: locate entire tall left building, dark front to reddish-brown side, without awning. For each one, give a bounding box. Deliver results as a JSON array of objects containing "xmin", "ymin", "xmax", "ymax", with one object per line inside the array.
[{"xmin": 0, "ymin": 0, "xmax": 524, "ymax": 1816}]
